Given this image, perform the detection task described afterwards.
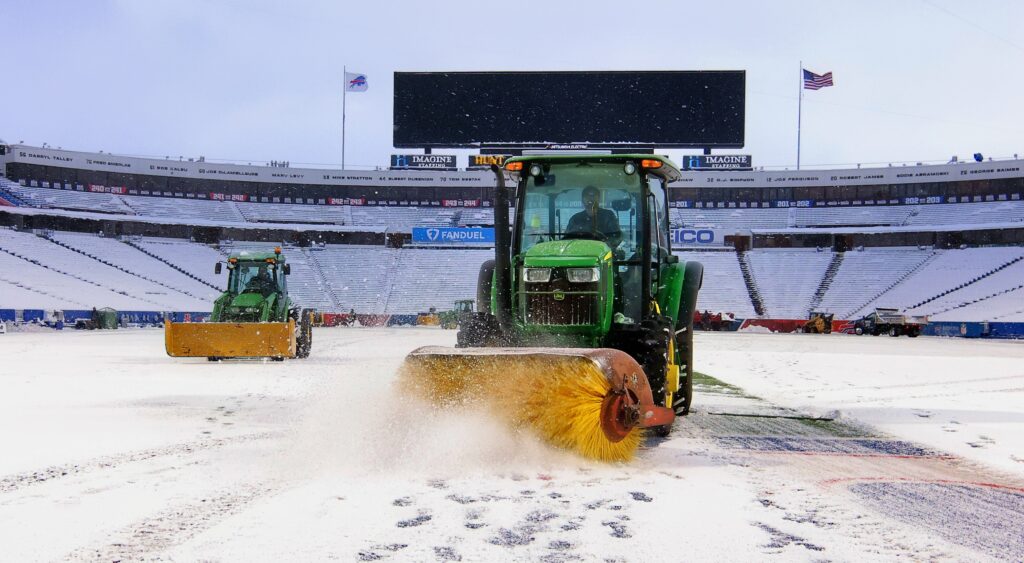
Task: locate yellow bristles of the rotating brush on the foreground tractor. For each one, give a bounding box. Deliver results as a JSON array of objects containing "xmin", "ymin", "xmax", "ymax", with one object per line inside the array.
[{"xmin": 400, "ymin": 354, "xmax": 643, "ymax": 462}]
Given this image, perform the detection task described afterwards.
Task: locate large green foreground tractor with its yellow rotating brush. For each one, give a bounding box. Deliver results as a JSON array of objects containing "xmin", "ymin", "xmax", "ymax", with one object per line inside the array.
[{"xmin": 401, "ymin": 154, "xmax": 703, "ymax": 461}]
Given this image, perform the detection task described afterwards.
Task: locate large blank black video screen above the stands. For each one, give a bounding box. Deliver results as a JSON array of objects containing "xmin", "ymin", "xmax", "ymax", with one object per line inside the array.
[{"xmin": 394, "ymin": 71, "xmax": 746, "ymax": 147}]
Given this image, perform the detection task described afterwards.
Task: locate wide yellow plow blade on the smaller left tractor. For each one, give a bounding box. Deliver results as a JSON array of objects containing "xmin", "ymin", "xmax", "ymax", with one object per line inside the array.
[{"xmin": 164, "ymin": 319, "xmax": 295, "ymax": 357}]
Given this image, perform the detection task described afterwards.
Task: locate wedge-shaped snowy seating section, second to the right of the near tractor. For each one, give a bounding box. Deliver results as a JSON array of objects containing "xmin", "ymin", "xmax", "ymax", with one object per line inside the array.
[{"xmin": 746, "ymin": 249, "xmax": 833, "ymax": 318}]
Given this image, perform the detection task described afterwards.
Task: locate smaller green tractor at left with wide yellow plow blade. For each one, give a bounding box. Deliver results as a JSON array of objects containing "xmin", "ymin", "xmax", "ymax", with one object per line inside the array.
[{"xmin": 164, "ymin": 247, "xmax": 315, "ymax": 361}]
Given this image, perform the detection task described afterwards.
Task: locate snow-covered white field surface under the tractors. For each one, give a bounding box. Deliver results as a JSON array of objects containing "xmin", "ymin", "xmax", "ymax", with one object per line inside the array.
[{"xmin": 0, "ymin": 329, "xmax": 1024, "ymax": 562}]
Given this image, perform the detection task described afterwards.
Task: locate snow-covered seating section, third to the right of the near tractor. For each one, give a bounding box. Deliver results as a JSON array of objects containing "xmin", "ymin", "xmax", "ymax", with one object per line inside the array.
[{"xmin": 818, "ymin": 247, "xmax": 936, "ymax": 318}]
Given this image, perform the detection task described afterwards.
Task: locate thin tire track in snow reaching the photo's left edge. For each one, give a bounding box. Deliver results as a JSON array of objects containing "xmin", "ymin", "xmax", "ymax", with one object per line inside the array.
[{"xmin": 0, "ymin": 432, "xmax": 275, "ymax": 493}]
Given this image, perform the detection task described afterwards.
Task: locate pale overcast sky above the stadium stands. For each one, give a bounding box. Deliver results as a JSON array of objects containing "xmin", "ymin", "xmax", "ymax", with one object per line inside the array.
[{"xmin": 0, "ymin": 0, "xmax": 1024, "ymax": 168}]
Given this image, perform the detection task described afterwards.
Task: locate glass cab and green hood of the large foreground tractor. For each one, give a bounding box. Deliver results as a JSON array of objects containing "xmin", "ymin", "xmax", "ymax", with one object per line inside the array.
[{"xmin": 506, "ymin": 155, "xmax": 679, "ymax": 345}]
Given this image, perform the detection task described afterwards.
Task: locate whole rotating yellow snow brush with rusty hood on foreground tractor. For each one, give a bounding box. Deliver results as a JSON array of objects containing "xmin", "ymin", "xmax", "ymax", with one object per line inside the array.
[{"xmin": 399, "ymin": 346, "xmax": 675, "ymax": 462}]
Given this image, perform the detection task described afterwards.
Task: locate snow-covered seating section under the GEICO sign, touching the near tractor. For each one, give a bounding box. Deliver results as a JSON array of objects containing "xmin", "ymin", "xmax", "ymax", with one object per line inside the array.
[{"xmin": 673, "ymin": 250, "xmax": 756, "ymax": 318}]
